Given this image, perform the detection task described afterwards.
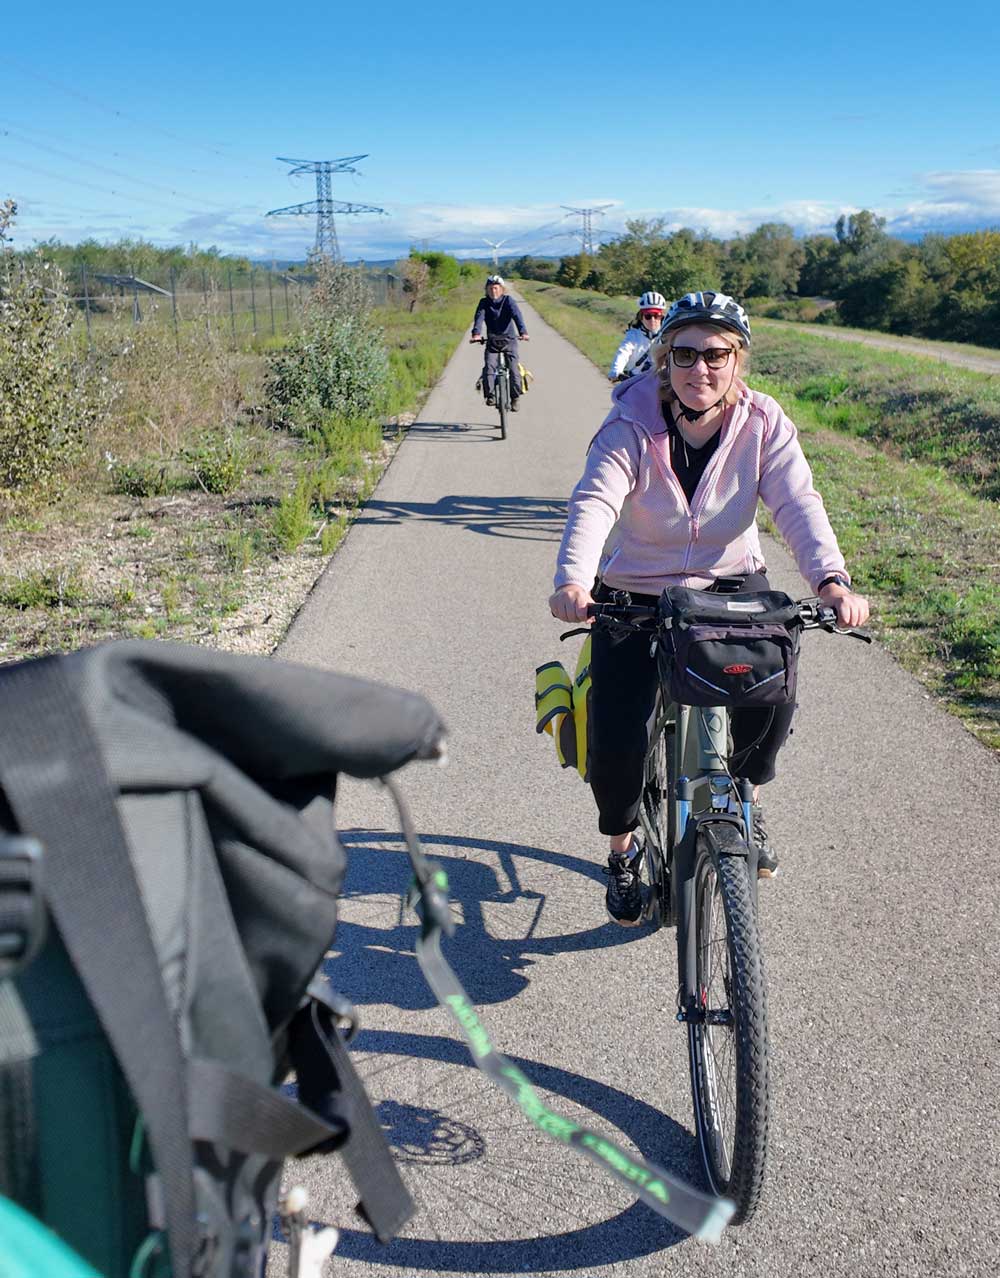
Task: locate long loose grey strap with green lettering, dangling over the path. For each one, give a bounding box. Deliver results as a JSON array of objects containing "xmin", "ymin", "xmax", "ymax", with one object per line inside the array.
[{"xmin": 382, "ymin": 777, "xmax": 735, "ymax": 1242}]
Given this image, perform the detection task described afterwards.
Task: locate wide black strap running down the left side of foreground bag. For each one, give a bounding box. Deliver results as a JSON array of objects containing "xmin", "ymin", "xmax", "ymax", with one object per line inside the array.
[{"xmin": 0, "ymin": 657, "xmax": 196, "ymax": 1278}]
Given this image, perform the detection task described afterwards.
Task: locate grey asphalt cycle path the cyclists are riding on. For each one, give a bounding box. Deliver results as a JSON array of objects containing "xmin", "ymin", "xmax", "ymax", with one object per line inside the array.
[{"xmin": 271, "ymin": 296, "xmax": 1000, "ymax": 1278}]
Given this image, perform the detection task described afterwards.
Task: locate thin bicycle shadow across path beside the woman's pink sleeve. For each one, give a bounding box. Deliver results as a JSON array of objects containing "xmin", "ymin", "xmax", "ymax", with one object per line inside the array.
[{"xmin": 354, "ymin": 493, "xmax": 566, "ymax": 542}]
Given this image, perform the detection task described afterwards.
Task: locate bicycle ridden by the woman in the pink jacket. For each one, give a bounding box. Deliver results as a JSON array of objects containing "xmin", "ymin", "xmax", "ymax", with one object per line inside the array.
[{"xmin": 583, "ymin": 590, "xmax": 871, "ymax": 1224}]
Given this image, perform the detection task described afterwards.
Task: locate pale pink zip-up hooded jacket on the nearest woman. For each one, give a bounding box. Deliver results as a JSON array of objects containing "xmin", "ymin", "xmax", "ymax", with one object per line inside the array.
[{"xmin": 555, "ymin": 371, "xmax": 848, "ymax": 594}]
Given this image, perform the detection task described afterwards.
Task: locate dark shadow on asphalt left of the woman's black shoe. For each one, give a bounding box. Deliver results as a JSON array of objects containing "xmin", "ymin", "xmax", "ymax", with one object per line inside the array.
[{"xmin": 324, "ymin": 831, "xmax": 630, "ymax": 1011}]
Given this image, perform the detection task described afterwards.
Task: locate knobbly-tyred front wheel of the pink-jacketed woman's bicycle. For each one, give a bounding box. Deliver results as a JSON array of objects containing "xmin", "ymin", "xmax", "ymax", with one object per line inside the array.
[{"xmin": 688, "ymin": 824, "xmax": 770, "ymax": 1224}]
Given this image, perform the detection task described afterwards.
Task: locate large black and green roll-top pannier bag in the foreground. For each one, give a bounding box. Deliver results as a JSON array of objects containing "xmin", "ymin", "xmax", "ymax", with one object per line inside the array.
[{"xmin": 0, "ymin": 642, "xmax": 442, "ymax": 1278}]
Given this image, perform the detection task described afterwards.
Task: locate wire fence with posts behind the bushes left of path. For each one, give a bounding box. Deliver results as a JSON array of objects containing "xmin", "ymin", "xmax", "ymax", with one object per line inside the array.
[{"xmin": 56, "ymin": 266, "xmax": 403, "ymax": 348}]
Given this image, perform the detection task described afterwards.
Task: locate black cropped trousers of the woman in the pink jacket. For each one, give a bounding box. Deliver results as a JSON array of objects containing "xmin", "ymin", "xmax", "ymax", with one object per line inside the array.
[{"xmin": 590, "ymin": 573, "xmax": 795, "ymax": 835}]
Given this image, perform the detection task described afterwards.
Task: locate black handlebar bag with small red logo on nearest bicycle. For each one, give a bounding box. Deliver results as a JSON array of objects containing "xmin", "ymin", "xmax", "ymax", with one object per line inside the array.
[{"xmin": 659, "ymin": 585, "xmax": 801, "ymax": 708}]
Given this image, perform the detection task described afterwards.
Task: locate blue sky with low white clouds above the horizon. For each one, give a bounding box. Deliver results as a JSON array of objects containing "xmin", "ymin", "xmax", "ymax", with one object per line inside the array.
[{"xmin": 0, "ymin": 0, "xmax": 1000, "ymax": 261}]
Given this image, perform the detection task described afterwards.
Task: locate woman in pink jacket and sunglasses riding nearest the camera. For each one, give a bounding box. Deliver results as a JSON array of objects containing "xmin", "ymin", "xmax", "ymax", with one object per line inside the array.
[{"xmin": 549, "ymin": 291, "xmax": 868, "ymax": 925}]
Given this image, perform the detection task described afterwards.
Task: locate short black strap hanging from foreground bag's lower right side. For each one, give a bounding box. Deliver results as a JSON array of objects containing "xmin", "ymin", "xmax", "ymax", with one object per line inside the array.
[{"xmin": 289, "ymin": 982, "xmax": 414, "ymax": 1242}]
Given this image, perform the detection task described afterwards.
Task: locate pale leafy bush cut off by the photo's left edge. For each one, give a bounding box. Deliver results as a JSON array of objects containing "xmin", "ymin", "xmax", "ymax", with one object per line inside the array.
[{"xmin": 0, "ymin": 203, "xmax": 98, "ymax": 500}]
